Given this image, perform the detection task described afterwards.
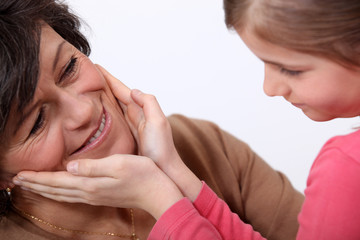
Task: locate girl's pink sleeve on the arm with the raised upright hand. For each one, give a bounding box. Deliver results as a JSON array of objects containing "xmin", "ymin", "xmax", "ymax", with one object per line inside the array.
[{"xmin": 194, "ymin": 182, "xmax": 264, "ymax": 240}]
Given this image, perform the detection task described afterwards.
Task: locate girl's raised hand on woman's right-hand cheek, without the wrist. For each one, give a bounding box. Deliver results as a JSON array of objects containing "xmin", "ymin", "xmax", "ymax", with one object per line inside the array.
[{"xmin": 98, "ymin": 66, "xmax": 179, "ymax": 169}]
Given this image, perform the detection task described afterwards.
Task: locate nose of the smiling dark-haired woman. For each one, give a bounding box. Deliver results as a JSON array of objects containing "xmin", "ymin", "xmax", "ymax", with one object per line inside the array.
[{"xmin": 61, "ymin": 93, "xmax": 94, "ymax": 131}]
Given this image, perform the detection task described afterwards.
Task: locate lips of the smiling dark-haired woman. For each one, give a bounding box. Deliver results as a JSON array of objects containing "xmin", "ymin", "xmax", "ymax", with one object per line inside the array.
[{"xmin": 73, "ymin": 108, "xmax": 112, "ymax": 155}]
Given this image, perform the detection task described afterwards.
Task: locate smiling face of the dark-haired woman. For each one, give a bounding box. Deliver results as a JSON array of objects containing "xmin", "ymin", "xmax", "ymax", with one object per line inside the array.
[{"xmin": 3, "ymin": 26, "xmax": 135, "ymax": 174}]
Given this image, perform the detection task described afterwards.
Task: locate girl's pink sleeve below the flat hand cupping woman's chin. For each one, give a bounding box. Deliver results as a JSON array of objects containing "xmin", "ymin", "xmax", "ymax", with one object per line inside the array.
[{"xmin": 148, "ymin": 198, "xmax": 222, "ymax": 240}]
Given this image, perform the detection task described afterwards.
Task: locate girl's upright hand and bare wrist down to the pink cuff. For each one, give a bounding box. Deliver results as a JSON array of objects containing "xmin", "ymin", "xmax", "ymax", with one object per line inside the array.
[{"xmin": 97, "ymin": 66, "xmax": 202, "ymax": 201}]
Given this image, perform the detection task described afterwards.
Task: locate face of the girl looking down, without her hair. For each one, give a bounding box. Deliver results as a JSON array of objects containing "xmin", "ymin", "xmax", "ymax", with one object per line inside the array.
[{"xmin": 238, "ymin": 30, "xmax": 360, "ymax": 121}]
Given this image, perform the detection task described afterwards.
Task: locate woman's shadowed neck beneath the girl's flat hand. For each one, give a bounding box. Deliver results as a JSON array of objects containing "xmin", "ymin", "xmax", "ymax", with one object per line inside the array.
[{"xmin": 12, "ymin": 188, "xmax": 133, "ymax": 239}]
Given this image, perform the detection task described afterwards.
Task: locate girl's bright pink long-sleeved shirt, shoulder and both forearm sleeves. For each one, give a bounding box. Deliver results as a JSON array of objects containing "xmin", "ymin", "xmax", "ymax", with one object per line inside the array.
[{"xmin": 148, "ymin": 130, "xmax": 360, "ymax": 240}]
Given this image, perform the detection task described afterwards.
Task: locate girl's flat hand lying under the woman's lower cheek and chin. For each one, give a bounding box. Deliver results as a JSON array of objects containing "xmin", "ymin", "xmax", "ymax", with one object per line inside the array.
[{"xmin": 14, "ymin": 155, "xmax": 183, "ymax": 219}]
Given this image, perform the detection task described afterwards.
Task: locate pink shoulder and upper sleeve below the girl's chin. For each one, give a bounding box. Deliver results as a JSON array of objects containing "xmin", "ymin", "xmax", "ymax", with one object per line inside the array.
[{"xmin": 297, "ymin": 148, "xmax": 360, "ymax": 240}]
